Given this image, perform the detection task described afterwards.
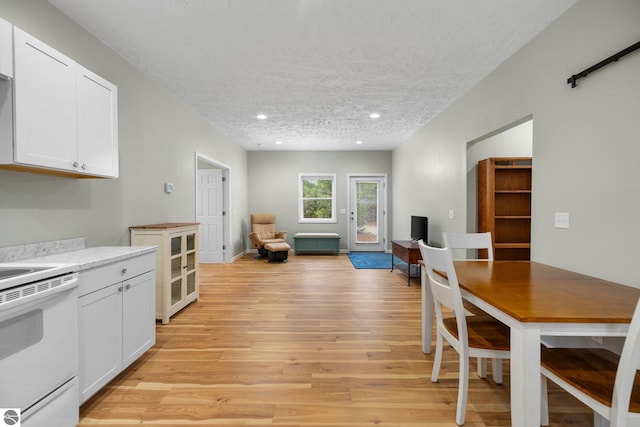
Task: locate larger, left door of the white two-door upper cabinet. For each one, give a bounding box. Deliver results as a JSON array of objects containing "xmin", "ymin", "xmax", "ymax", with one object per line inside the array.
[{"xmin": 14, "ymin": 28, "xmax": 77, "ymax": 171}]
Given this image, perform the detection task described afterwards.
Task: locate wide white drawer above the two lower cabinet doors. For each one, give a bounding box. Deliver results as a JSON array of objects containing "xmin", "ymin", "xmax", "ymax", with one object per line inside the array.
[{"xmin": 78, "ymin": 253, "xmax": 155, "ymax": 296}]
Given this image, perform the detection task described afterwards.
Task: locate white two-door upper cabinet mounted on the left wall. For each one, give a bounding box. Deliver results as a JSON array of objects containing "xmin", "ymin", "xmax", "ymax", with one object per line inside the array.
[{"xmin": 0, "ymin": 27, "xmax": 118, "ymax": 178}]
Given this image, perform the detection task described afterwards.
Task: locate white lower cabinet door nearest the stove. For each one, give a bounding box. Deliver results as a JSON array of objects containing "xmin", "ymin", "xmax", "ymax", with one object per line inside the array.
[{"xmin": 78, "ymin": 283, "xmax": 122, "ymax": 402}]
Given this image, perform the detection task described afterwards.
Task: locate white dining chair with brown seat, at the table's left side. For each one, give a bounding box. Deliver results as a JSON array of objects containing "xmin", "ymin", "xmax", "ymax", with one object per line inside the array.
[{"xmin": 418, "ymin": 241, "xmax": 509, "ymax": 425}]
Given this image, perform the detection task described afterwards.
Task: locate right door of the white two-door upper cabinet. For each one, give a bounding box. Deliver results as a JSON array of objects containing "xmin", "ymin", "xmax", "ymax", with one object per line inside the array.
[{"xmin": 76, "ymin": 65, "xmax": 118, "ymax": 178}]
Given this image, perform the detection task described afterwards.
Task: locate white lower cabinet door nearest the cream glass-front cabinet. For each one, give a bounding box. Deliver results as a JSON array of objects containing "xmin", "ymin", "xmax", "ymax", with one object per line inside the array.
[{"xmin": 122, "ymin": 271, "xmax": 156, "ymax": 369}]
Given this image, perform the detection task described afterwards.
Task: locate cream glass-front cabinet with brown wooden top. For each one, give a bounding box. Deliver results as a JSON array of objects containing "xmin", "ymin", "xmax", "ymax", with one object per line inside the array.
[{"xmin": 129, "ymin": 223, "xmax": 199, "ymax": 324}]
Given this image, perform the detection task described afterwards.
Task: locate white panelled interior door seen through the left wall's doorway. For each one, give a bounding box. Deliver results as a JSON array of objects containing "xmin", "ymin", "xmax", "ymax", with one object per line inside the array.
[{"xmin": 196, "ymin": 169, "xmax": 224, "ymax": 264}]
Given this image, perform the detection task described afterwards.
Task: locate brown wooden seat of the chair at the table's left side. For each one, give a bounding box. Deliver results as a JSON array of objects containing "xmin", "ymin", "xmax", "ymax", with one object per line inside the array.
[{"xmin": 443, "ymin": 315, "xmax": 511, "ymax": 352}]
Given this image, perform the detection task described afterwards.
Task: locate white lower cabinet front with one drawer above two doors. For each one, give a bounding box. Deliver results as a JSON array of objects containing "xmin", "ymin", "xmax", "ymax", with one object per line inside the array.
[{"xmin": 79, "ymin": 253, "xmax": 155, "ymax": 403}]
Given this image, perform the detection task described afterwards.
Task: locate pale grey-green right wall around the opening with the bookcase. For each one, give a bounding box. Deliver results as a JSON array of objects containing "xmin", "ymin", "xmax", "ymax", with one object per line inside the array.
[{"xmin": 392, "ymin": 0, "xmax": 640, "ymax": 287}]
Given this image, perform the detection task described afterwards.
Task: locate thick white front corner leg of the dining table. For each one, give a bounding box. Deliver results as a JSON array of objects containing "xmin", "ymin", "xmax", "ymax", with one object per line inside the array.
[{"xmin": 510, "ymin": 324, "xmax": 540, "ymax": 427}]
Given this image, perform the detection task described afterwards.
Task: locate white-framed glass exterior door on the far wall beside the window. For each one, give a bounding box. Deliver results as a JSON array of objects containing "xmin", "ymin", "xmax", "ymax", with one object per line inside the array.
[{"xmin": 349, "ymin": 176, "xmax": 386, "ymax": 252}]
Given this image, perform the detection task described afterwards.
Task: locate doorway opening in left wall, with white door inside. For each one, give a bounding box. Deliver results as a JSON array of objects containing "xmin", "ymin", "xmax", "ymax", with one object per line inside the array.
[{"xmin": 195, "ymin": 152, "xmax": 231, "ymax": 264}]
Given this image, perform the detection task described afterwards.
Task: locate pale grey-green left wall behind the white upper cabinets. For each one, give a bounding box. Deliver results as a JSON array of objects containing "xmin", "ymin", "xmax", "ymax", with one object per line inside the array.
[{"xmin": 0, "ymin": 0, "xmax": 247, "ymax": 254}]
